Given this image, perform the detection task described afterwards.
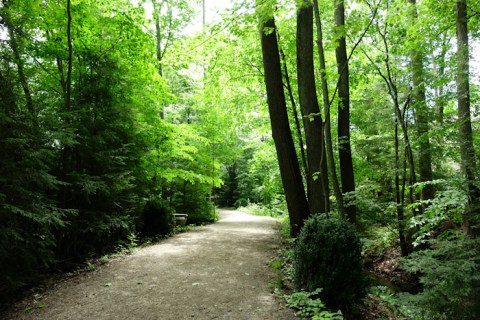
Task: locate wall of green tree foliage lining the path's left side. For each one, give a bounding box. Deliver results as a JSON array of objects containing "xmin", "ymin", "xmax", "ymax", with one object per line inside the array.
[{"xmin": 0, "ymin": 0, "xmax": 219, "ymax": 300}]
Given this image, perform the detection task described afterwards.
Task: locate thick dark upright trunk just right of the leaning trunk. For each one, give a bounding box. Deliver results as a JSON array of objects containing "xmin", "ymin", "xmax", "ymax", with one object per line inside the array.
[{"xmin": 297, "ymin": 3, "xmax": 328, "ymax": 213}]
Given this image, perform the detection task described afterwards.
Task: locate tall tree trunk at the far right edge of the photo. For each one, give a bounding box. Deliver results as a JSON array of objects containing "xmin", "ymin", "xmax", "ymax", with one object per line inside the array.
[{"xmin": 456, "ymin": 0, "xmax": 480, "ymax": 235}]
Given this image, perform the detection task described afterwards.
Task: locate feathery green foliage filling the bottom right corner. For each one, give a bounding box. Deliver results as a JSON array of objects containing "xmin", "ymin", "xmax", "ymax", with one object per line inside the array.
[{"xmin": 403, "ymin": 238, "xmax": 480, "ymax": 319}]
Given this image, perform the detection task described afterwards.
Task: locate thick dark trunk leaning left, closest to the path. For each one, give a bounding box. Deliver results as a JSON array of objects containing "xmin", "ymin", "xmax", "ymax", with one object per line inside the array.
[{"xmin": 260, "ymin": 17, "xmax": 310, "ymax": 237}]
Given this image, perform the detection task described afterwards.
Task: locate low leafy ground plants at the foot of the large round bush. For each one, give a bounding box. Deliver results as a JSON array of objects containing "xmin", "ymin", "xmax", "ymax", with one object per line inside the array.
[{"xmin": 284, "ymin": 289, "xmax": 343, "ymax": 320}]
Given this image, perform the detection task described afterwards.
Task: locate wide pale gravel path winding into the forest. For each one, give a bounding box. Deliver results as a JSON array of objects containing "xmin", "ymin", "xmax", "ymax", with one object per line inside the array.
[{"xmin": 6, "ymin": 210, "xmax": 296, "ymax": 320}]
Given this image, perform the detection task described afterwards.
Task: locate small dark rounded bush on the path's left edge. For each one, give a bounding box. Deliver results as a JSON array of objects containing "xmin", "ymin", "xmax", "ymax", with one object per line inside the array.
[{"xmin": 142, "ymin": 199, "xmax": 174, "ymax": 237}]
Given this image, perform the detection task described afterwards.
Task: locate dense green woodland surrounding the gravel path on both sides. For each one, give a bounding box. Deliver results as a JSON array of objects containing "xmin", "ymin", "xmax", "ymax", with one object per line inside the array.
[{"xmin": 0, "ymin": 0, "xmax": 480, "ymax": 319}]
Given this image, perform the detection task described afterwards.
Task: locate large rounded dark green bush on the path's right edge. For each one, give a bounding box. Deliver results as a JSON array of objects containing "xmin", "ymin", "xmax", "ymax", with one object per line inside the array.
[{"xmin": 294, "ymin": 215, "xmax": 366, "ymax": 310}]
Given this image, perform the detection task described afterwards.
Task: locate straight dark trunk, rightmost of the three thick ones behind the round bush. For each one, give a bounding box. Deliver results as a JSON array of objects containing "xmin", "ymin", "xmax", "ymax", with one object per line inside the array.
[{"xmin": 334, "ymin": 0, "xmax": 357, "ymax": 224}]
